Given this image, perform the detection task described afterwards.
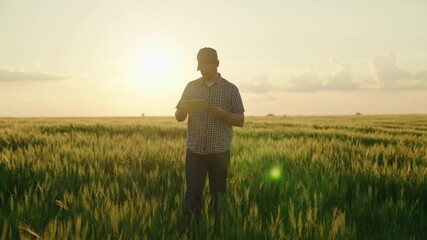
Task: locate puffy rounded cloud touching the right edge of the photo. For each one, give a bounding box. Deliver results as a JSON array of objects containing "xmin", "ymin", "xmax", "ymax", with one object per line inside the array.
[{"xmin": 371, "ymin": 55, "xmax": 427, "ymax": 90}]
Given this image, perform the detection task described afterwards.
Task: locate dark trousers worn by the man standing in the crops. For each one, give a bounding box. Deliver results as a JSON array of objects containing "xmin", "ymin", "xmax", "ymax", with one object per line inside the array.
[{"xmin": 183, "ymin": 149, "xmax": 230, "ymax": 214}]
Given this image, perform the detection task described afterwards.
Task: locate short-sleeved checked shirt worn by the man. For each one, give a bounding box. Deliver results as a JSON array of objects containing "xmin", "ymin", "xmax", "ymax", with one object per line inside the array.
[{"xmin": 176, "ymin": 75, "xmax": 245, "ymax": 154}]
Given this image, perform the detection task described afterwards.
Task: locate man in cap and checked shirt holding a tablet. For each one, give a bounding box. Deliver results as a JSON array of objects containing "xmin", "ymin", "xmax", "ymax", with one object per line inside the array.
[{"xmin": 175, "ymin": 47, "xmax": 245, "ymax": 226}]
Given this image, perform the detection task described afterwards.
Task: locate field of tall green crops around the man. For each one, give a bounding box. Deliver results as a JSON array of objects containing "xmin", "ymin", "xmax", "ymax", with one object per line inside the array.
[{"xmin": 0, "ymin": 115, "xmax": 427, "ymax": 240}]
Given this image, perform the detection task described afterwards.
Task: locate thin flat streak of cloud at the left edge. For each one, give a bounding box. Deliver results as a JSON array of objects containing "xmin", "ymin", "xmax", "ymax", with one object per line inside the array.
[{"xmin": 0, "ymin": 67, "xmax": 70, "ymax": 82}]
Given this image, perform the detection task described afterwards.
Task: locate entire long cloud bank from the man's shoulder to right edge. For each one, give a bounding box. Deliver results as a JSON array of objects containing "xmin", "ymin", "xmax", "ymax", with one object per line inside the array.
[{"xmin": 239, "ymin": 55, "xmax": 427, "ymax": 94}]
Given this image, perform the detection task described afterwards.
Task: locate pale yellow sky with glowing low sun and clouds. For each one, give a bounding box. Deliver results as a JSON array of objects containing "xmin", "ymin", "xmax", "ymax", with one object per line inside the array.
[{"xmin": 0, "ymin": 0, "xmax": 427, "ymax": 117}]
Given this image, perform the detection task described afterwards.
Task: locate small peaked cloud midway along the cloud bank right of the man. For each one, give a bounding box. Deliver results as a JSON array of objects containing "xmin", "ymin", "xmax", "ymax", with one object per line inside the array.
[{"xmin": 283, "ymin": 59, "xmax": 360, "ymax": 92}]
